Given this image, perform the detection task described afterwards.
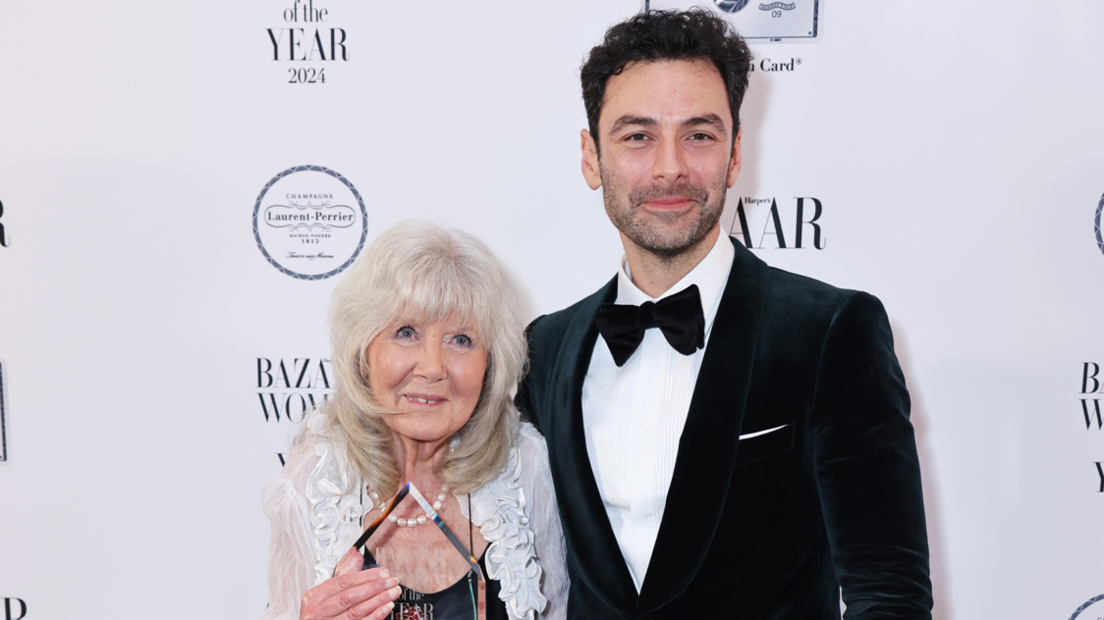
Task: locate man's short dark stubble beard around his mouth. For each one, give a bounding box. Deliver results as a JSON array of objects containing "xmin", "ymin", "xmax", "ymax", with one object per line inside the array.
[{"xmin": 599, "ymin": 168, "xmax": 726, "ymax": 260}]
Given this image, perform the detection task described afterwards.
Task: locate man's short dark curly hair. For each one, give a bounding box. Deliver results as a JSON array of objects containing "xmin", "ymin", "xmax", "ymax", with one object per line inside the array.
[{"xmin": 582, "ymin": 9, "xmax": 752, "ymax": 152}]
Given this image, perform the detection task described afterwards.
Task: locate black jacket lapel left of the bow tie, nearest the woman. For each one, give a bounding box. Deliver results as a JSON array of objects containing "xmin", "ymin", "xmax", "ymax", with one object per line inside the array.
[{"xmin": 546, "ymin": 278, "xmax": 637, "ymax": 617}]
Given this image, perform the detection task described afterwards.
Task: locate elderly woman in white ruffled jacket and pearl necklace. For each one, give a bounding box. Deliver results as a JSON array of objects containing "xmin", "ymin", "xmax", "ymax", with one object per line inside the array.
[{"xmin": 262, "ymin": 222, "xmax": 567, "ymax": 620}]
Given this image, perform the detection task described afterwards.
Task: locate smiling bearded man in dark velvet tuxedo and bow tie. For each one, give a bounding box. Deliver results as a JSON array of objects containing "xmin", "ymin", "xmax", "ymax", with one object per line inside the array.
[{"xmin": 518, "ymin": 11, "xmax": 932, "ymax": 620}]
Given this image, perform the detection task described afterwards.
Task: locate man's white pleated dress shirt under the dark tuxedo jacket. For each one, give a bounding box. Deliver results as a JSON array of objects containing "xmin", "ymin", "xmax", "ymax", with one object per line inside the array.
[{"xmin": 583, "ymin": 231, "xmax": 735, "ymax": 591}]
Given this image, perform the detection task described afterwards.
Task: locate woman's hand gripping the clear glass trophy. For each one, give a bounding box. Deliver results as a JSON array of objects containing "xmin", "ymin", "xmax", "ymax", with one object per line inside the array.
[{"xmin": 299, "ymin": 549, "xmax": 402, "ymax": 620}]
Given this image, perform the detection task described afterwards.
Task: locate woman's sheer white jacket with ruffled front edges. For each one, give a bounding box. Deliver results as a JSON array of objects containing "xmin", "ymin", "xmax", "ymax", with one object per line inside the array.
[{"xmin": 261, "ymin": 411, "xmax": 567, "ymax": 620}]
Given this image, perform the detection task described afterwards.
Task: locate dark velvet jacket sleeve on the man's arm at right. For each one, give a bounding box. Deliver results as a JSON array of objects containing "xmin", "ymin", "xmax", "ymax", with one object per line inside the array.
[{"xmin": 811, "ymin": 292, "xmax": 932, "ymax": 620}]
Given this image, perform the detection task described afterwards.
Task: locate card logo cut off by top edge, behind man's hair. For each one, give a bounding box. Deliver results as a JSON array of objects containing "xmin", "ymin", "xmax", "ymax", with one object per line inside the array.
[{"xmin": 644, "ymin": 0, "xmax": 820, "ymax": 43}]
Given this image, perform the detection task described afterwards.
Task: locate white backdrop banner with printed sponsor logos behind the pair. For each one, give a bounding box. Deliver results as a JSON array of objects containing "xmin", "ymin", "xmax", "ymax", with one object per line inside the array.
[{"xmin": 0, "ymin": 0, "xmax": 1104, "ymax": 620}]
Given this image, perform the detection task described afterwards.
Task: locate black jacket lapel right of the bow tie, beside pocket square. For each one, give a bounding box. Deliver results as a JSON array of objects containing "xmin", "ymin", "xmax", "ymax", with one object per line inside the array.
[{"xmin": 635, "ymin": 238, "xmax": 767, "ymax": 618}]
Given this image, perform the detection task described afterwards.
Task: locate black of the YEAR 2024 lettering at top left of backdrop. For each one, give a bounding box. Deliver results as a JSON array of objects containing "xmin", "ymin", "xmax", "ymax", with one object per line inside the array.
[{"xmin": 265, "ymin": 0, "xmax": 349, "ymax": 84}]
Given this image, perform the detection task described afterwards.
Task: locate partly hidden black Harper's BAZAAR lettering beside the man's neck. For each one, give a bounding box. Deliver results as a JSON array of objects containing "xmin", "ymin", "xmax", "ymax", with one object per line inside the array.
[{"xmin": 729, "ymin": 196, "xmax": 827, "ymax": 249}]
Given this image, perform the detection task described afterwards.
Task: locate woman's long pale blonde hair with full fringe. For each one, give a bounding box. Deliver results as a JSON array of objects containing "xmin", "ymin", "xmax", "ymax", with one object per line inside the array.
[{"xmin": 322, "ymin": 220, "xmax": 526, "ymax": 496}]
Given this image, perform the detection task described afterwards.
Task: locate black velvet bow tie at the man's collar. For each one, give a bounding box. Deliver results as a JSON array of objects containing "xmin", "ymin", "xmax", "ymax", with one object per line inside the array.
[{"xmin": 594, "ymin": 285, "xmax": 705, "ymax": 366}]
